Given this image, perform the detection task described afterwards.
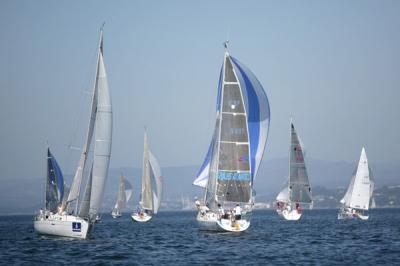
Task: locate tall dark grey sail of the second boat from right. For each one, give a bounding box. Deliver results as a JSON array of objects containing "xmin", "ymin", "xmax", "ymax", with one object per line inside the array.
[{"xmin": 289, "ymin": 123, "xmax": 312, "ymax": 203}]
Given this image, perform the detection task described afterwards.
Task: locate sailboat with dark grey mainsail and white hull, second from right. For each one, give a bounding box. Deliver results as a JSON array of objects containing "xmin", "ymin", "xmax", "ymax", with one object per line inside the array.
[{"xmin": 276, "ymin": 122, "xmax": 313, "ymax": 220}]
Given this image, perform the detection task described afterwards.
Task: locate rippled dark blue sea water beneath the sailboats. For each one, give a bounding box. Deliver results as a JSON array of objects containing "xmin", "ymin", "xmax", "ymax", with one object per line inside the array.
[{"xmin": 0, "ymin": 209, "xmax": 400, "ymax": 265}]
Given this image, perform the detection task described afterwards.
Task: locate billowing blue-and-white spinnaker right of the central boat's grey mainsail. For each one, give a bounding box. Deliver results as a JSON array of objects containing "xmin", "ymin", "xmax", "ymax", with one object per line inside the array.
[{"xmin": 231, "ymin": 57, "xmax": 270, "ymax": 180}]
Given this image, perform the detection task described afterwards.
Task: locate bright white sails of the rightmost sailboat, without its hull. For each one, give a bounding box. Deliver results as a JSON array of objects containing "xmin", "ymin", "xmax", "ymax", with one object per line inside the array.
[{"xmin": 343, "ymin": 148, "xmax": 374, "ymax": 210}]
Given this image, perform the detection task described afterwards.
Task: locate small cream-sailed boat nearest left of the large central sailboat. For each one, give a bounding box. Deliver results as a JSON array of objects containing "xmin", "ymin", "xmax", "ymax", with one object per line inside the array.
[{"xmin": 131, "ymin": 132, "xmax": 162, "ymax": 222}]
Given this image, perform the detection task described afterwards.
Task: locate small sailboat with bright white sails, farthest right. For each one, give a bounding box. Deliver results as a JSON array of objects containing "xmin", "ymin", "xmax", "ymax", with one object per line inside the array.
[{"xmin": 338, "ymin": 147, "xmax": 374, "ymax": 220}]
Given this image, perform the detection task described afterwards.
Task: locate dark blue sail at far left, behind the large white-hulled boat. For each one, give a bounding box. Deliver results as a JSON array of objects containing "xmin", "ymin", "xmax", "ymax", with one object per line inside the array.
[{"xmin": 46, "ymin": 148, "xmax": 64, "ymax": 213}]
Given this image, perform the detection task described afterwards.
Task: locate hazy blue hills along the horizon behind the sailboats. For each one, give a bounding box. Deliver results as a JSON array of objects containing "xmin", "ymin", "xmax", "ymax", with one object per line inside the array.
[{"xmin": 0, "ymin": 158, "xmax": 400, "ymax": 214}]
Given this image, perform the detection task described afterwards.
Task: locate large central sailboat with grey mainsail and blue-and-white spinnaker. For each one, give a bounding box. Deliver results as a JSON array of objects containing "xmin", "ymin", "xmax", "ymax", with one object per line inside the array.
[{"xmin": 193, "ymin": 42, "xmax": 270, "ymax": 232}]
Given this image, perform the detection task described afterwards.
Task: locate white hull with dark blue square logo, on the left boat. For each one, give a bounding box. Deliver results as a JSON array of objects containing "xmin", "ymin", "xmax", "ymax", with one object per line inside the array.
[{"xmin": 33, "ymin": 214, "xmax": 89, "ymax": 239}]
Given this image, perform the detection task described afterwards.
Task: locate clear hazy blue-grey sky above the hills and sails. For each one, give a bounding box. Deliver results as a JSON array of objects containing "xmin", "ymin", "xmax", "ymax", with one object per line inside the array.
[{"xmin": 0, "ymin": 0, "xmax": 400, "ymax": 179}]
